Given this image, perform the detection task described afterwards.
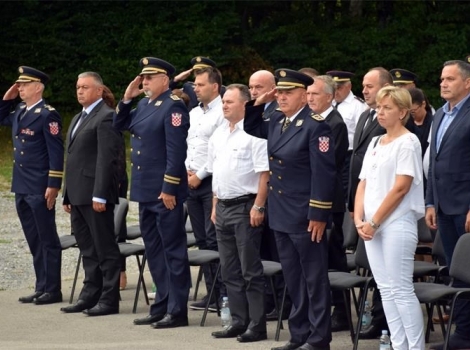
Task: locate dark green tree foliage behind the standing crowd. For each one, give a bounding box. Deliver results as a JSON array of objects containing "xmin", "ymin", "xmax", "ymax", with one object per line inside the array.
[{"xmin": 0, "ymin": 0, "xmax": 470, "ymax": 185}]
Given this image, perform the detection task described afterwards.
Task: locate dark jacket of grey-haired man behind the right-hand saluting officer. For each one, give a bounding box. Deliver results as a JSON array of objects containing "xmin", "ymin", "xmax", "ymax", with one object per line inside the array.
[{"xmin": 325, "ymin": 109, "xmax": 349, "ymax": 213}]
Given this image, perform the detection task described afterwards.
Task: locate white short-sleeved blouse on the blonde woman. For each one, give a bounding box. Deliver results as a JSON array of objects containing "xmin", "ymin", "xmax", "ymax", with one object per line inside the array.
[{"xmin": 359, "ymin": 133, "xmax": 424, "ymax": 226}]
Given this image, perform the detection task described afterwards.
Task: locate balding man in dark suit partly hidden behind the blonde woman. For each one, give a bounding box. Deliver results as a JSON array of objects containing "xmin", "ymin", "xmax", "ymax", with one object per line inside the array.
[{"xmin": 348, "ymin": 67, "xmax": 393, "ymax": 339}]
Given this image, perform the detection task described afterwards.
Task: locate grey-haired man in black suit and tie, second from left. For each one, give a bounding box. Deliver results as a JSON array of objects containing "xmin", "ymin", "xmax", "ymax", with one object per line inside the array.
[{"xmin": 61, "ymin": 72, "xmax": 122, "ymax": 316}]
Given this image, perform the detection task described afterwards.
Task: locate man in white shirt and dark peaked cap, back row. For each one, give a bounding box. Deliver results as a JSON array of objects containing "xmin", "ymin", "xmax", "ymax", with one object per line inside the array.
[{"xmin": 326, "ymin": 70, "xmax": 367, "ymax": 200}]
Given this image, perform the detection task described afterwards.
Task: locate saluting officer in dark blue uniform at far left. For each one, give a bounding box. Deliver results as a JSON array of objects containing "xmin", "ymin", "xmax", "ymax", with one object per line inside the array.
[{"xmin": 0, "ymin": 66, "xmax": 64, "ymax": 305}]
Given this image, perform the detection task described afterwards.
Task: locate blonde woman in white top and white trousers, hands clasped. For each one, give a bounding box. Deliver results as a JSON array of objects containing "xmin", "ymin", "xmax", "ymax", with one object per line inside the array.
[{"xmin": 354, "ymin": 86, "xmax": 424, "ymax": 350}]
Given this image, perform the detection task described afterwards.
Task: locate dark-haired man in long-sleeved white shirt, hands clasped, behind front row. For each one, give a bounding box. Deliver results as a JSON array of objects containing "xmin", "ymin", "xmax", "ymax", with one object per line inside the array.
[{"xmin": 185, "ymin": 67, "xmax": 224, "ymax": 310}]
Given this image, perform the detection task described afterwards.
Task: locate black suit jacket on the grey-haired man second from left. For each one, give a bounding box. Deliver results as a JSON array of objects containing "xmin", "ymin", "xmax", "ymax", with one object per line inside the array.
[{"xmin": 64, "ymin": 101, "xmax": 122, "ymax": 205}]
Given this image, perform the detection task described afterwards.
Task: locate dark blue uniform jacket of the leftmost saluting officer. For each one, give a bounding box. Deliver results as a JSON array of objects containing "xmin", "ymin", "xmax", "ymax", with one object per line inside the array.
[{"xmin": 0, "ymin": 100, "xmax": 64, "ymax": 195}]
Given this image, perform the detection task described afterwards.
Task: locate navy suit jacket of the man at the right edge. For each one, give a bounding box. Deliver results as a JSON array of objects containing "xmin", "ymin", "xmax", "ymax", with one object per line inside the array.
[{"xmin": 426, "ymin": 99, "xmax": 470, "ymax": 215}]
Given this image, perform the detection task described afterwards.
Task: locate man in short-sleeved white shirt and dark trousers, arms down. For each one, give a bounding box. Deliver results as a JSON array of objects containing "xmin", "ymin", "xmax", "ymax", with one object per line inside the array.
[{"xmin": 207, "ymin": 84, "xmax": 269, "ymax": 342}]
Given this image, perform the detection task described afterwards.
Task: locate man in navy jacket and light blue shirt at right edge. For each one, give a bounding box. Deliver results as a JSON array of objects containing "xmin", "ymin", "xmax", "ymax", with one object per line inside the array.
[{"xmin": 426, "ymin": 60, "xmax": 470, "ymax": 350}]
